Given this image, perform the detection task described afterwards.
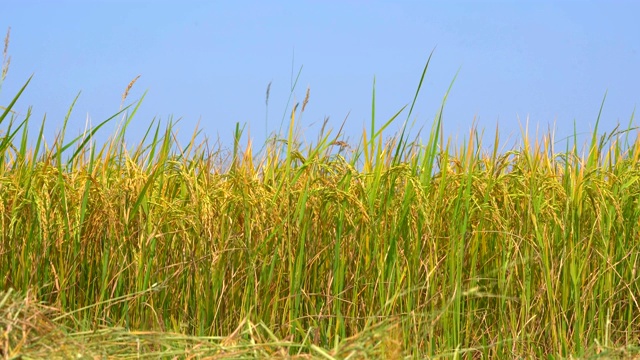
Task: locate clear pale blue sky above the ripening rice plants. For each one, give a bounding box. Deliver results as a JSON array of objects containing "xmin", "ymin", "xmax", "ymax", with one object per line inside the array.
[{"xmin": 0, "ymin": 0, "xmax": 640, "ymax": 152}]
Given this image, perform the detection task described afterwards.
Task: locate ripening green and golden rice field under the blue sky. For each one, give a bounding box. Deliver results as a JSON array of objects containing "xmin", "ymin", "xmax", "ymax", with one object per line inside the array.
[{"xmin": 0, "ymin": 35, "xmax": 640, "ymax": 359}]
